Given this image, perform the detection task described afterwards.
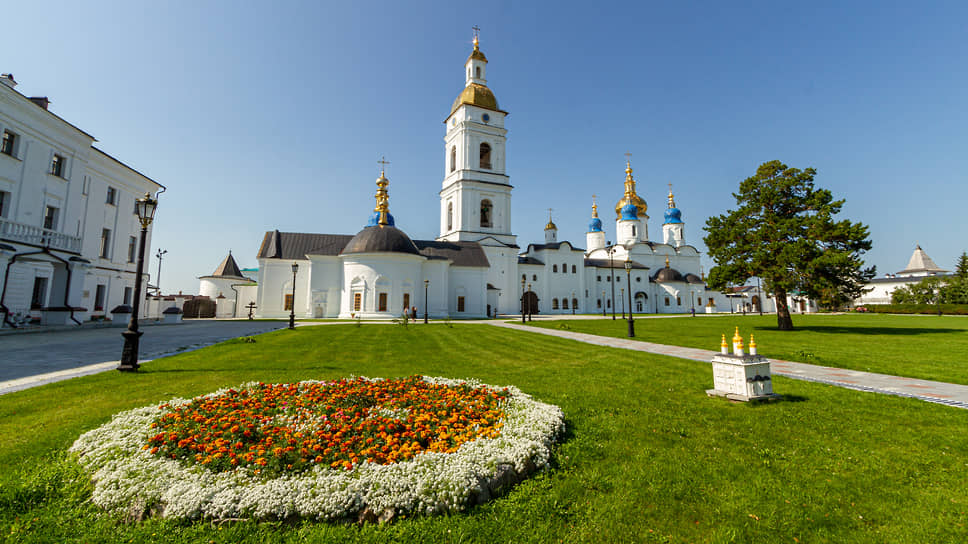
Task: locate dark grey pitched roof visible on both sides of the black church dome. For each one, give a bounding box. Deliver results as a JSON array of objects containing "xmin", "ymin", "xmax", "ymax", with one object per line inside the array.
[{"xmin": 257, "ymin": 229, "xmax": 490, "ymax": 267}]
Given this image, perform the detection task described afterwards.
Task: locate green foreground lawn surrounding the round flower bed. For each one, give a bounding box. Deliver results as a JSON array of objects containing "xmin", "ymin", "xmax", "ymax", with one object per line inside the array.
[{"xmin": 0, "ymin": 320, "xmax": 968, "ymax": 542}]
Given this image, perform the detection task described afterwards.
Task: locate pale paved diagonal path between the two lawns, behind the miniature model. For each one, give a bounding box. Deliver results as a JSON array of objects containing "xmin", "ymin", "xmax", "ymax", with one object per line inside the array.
[{"xmin": 485, "ymin": 321, "xmax": 968, "ymax": 408}]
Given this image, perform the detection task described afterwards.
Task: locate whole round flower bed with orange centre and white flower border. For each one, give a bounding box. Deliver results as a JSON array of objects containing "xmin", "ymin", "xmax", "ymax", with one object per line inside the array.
[{"xmin": 71, "ymin": 376, "xmax": 564, "ymax": 521}]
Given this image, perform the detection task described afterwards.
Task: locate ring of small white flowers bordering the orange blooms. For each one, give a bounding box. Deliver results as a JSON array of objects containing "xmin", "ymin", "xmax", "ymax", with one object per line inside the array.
[{"xmin": 71, "ymin": 377, "xmax": 565, "ymax": 520}]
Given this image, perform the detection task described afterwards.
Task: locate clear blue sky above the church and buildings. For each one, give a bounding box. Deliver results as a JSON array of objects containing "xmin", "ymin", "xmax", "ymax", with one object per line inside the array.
[{"xmin": 0, "ymin": 0, "xmax": 968, "ymax": 293}]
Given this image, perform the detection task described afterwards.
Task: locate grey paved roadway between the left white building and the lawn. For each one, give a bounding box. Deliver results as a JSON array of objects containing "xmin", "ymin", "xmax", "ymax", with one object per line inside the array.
[{"xmin": 0, "ymin": 321, "xmax": 287, "ymax": 394}]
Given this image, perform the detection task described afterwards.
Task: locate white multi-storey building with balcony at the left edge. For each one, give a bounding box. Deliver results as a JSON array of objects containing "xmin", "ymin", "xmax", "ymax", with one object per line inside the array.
[{"xmin": 0, "ymin": 74, "xmax": 163, "ymax": 326}]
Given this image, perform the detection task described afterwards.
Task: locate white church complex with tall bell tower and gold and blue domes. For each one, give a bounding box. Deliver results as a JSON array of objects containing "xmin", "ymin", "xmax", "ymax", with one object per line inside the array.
[{"xmin": 248, "ymin": 37, "xmax": 800, "ymax": 319}]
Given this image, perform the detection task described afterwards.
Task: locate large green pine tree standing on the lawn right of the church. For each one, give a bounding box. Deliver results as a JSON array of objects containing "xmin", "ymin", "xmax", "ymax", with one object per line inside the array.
[{"xmin": 704, "ymin": 161, "xmax": 874, "ymax": 330}]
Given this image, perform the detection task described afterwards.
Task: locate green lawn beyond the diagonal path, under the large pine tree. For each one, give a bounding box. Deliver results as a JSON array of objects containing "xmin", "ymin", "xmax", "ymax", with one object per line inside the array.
[{"xmin": 529, "ymin": 314, "xmax": 968, "ymax": 385}]
